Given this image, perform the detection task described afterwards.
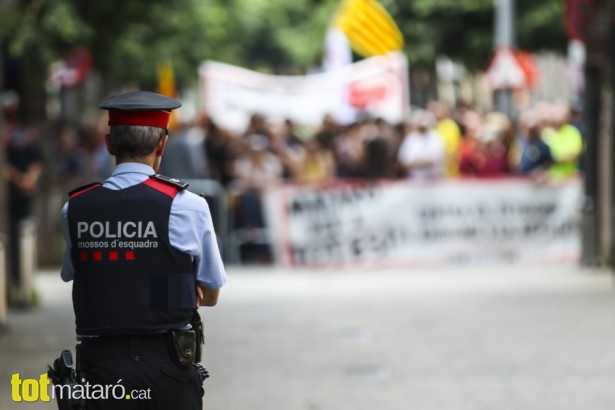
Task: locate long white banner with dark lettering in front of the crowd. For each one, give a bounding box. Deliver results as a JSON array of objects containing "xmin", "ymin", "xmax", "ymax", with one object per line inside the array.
[{"xmin": 265, "ymin": 178, "xmax": 582, "ymax": 266}]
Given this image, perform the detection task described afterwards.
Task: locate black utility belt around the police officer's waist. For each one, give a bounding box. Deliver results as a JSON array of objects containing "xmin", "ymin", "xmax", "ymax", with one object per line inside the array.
[{"xmin": 81, "ymin": 330, "xmax": 200, "ymax": 366}]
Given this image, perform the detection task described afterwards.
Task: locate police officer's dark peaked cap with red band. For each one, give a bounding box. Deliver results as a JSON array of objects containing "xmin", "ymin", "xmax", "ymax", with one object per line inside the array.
[{"xmin": 98, "ymin": 91, "xmax": 182, "ymax": 129}]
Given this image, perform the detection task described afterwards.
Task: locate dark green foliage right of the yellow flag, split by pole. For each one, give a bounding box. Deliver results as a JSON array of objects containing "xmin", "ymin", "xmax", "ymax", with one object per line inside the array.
[{"xmin": 392, "ymin": 0, "xmax": 566, "ymax": 70}]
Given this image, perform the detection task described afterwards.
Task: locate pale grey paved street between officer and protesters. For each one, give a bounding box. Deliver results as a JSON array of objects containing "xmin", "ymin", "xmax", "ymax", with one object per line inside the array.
[{"xmin": 0, "ymin": 265, "xmax": 615, "ymax": 410}]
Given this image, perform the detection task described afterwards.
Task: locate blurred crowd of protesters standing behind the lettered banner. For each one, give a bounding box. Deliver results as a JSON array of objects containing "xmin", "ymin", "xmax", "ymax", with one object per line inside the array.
[{"xmin": 2, "ymin": 93, "xmax": 583, "ymax": 266}]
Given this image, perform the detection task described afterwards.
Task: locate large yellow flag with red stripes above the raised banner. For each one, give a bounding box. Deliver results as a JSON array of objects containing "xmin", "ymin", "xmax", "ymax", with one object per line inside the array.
[{"xmin": 333, "ymin": 0, "xmax": 404, "ymax": 57}]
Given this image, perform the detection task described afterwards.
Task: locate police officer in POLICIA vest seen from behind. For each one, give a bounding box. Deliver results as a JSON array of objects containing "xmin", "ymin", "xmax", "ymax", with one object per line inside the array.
[{"xmin": 61, "ymin": 91, "xmax": 227, "ymax": 409}]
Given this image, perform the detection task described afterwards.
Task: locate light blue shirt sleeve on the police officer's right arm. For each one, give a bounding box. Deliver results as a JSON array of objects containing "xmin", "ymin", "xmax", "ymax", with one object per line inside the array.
[{"xmin": 169, "ymin": 191, "xmax": 227, "ymax": 289}]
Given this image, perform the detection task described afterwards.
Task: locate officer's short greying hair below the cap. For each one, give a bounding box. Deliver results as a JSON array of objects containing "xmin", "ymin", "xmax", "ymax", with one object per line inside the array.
[{"xmin": 109, "ymin": 125, "xmax": 166, "ymax": 158}]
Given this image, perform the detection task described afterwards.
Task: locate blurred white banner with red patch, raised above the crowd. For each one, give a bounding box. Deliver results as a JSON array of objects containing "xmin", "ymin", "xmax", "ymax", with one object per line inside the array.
[{"xmin": 199, "ymin": 53, "xmax": 409, "ymax": 132}]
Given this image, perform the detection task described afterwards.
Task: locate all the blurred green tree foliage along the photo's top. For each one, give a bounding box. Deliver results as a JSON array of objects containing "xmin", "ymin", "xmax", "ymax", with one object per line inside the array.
[{"xmin": 0, "ymin": 0, "xmax": 566, "ymax": 97}]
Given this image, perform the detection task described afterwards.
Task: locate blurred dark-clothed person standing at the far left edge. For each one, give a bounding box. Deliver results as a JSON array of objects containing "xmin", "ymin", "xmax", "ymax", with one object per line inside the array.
[{"xmin": 0, "ymin": 91, "xmax": 43, "ymax": 294}]
